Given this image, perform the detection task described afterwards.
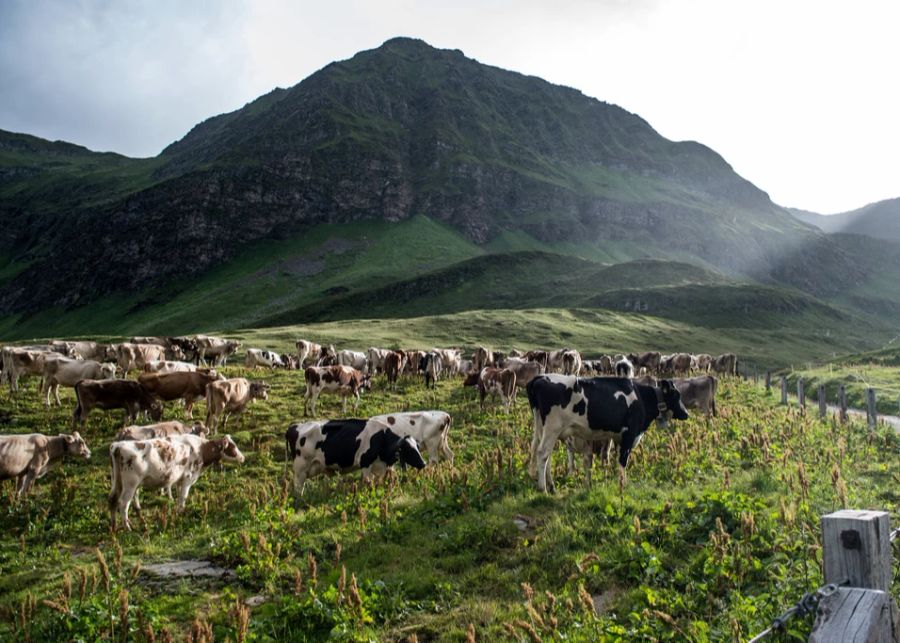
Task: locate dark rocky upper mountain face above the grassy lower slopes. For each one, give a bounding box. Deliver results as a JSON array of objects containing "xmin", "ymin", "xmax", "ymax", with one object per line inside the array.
[{"xmin": 0, "ymin": 39, "xmax": 860, "ymax": 313}]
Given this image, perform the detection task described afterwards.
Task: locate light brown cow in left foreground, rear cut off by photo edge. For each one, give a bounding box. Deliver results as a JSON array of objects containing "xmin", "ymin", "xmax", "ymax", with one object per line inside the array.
[{"xmin": 0, "ymin": 431, "xmax": 91, "ymax": 498}]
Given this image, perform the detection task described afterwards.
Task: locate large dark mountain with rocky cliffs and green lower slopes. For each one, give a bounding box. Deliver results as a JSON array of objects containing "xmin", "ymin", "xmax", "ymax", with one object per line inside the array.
[{"xmin": 0, "ymin": 38, "xmax": 900, "ymax": 348}]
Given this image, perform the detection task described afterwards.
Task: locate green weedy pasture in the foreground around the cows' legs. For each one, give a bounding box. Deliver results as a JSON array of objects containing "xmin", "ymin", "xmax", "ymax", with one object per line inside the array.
[{"xmin": 0, "ymin": 360, "xmax": 900, "ymax": 641}]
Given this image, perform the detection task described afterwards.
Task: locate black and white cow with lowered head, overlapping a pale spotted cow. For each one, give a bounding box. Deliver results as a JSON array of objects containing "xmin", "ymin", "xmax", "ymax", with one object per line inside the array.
[{"xmin": 288, "ymin": 420, "xmax": 425, "ymax": 497}]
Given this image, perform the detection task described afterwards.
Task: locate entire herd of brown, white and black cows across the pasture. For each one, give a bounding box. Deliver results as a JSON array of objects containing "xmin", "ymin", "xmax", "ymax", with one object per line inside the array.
[{"xmin": 0, "ymin": 335, "xmax": 737, "ymax": 529}]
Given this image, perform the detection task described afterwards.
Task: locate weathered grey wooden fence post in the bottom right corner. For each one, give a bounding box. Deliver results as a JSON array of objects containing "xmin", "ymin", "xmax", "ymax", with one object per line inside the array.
[{"xmin": 809, "ymin": 509, "xmax": 900, "ymax": 643}]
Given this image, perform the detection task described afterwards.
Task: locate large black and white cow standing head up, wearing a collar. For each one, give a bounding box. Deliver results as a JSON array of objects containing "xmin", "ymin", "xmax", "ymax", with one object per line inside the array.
[{"xmin": 526, "ymin": 374, "xmax": 688, "ymax": 491}]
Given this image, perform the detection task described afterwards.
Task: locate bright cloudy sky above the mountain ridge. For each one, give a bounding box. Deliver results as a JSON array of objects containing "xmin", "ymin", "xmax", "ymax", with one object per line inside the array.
[{"xmin": 0, "ymin": 0, "xmax": 900, "ymax": 214}]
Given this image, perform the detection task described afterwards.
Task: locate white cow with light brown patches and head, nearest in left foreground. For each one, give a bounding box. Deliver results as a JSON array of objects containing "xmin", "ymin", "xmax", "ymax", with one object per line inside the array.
[{"xmin": 109, "ymin": 435, "xmax": 244, "ymax": 531}]
